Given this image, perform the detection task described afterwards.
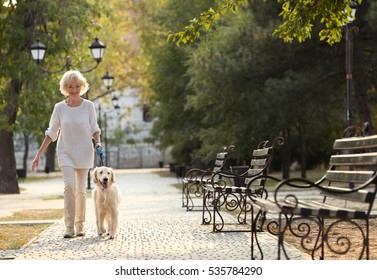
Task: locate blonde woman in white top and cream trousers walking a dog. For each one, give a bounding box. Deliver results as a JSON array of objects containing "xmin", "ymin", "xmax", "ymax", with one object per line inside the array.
[{"xmin": 32, "ymin": 70, "xmax": 101, "ymax": 238}]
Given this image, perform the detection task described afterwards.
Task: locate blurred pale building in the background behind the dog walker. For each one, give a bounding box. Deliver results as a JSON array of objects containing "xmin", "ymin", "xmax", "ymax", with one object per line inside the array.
[{"xmin": 96, "ymin": 88, "xmax": 171, "ymax": 168}]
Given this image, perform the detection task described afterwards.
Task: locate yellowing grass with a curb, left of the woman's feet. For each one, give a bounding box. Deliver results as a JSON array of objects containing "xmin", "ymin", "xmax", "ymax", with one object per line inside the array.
[{"xmin": 0, "ymin": 209, "xmax": 63, "ymax": 250}]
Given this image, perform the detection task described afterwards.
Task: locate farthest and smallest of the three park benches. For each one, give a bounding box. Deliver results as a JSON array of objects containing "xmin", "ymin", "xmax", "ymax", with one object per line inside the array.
[{"xmin": 182, "ymin": 145, "xmax": 234, "ymax": 211}]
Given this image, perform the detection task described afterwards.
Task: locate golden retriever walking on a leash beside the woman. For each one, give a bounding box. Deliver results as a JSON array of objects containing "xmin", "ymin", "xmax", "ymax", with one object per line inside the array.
[{"xmin": 93, "ymin": 166, "xmax": 121, "ymax": 239}]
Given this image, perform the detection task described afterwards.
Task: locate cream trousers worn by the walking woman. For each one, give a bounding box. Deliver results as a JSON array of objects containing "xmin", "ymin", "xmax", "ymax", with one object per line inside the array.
[{"xmin": 61, "ymin": 166, "xmax": 89, "ymax": 233}]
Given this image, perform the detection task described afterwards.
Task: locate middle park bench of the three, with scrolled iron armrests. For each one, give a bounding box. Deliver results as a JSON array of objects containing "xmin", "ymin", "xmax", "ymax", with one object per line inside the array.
[{"xmin": 202, "ymin": 137, "xmax": 284, "ymax": 232}]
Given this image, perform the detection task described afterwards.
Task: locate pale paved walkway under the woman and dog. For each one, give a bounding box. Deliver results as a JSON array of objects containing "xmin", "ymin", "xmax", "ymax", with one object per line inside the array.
[{"xmin": 0, "ymin": 169, "xmax": 309, "ymax": 260}]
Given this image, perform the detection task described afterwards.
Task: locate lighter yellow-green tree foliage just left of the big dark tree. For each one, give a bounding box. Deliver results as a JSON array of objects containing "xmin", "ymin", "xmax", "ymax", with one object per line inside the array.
[{"xmin": 137, "ymin": 0, "xmax": 212, "ymax": 162}]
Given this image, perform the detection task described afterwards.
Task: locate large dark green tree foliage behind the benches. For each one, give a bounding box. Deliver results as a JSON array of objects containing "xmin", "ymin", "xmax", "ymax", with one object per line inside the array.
[{"xmin": 186, "ymin": 1, "xmax": 338, "ymax": 164}]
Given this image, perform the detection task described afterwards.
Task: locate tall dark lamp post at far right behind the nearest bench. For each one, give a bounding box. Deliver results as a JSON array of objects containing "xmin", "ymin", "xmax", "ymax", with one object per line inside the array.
[{"xmin": 344, "ymin": 1, "xmax": 358, "ymax": 126}]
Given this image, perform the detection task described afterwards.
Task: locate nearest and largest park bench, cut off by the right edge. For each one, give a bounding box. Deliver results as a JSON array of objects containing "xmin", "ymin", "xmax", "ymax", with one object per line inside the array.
[{"xmin": 250, "ymin": 132, "xmax": 377, "ymax": 259}]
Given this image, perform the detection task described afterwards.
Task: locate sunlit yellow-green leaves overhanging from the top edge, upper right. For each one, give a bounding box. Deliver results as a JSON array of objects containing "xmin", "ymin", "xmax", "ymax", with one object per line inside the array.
[{"xmin": 167, "ymin": 0, "xmax": 362, "ymax": 45}]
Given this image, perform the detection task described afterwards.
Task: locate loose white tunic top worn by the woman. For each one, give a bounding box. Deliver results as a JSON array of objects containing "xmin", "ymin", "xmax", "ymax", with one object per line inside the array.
[{"xmin": 45, "ymin": 99, "xmax": 101, "ymax": 169}]
